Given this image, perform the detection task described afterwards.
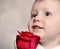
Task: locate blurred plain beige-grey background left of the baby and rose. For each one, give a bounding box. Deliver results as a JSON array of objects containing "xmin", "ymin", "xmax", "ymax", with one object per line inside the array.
[{"xmin": 0, "ymin": 0, "xmax": 34, "ymax": 49}]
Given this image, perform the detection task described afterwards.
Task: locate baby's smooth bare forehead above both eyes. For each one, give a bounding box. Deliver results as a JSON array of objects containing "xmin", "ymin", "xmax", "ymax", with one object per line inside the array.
[{"xmin": 32, "ymin": 0, "xmax": 60, "ymax": 9}]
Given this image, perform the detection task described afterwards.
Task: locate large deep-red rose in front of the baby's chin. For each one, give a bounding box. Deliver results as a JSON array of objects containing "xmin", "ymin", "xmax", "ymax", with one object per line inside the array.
[{"xmin": 16, "ymin": 31, "xmax": 40, "ymax": 49}]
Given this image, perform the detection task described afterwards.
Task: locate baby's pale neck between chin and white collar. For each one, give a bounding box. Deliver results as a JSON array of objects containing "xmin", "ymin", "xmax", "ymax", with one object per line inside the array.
[{"xmin": 41, "ymin": 37, "xmax": 60, "ymax": 49}]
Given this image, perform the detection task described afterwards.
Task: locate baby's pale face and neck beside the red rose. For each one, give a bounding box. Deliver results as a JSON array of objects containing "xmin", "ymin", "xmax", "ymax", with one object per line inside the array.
[{"xmin": 28, "ymin": 0, "xmax": 60, "ymax": 49}]
